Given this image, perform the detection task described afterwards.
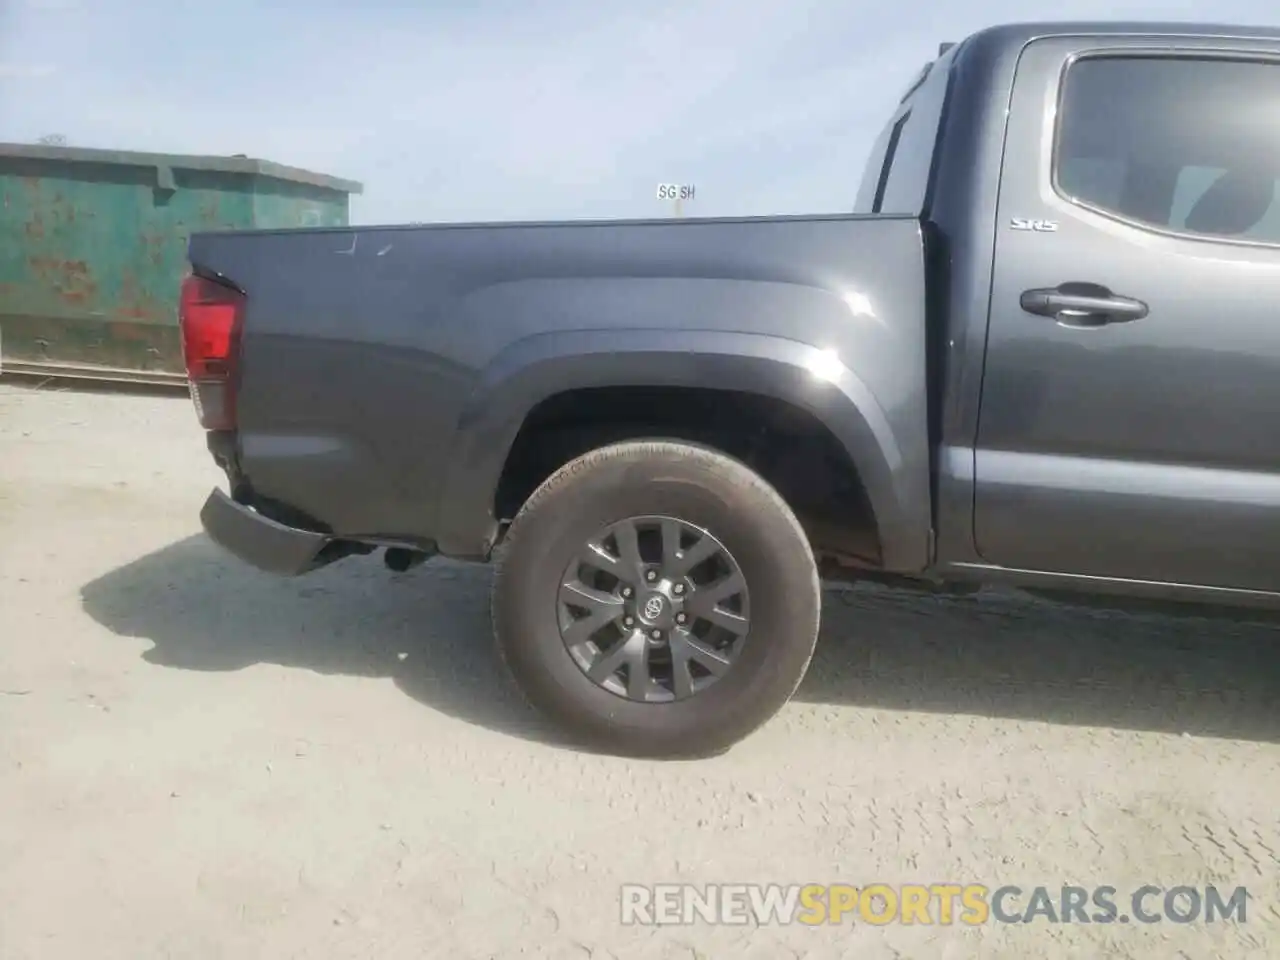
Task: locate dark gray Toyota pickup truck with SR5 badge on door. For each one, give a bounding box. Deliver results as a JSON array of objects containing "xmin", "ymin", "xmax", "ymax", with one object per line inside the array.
[{"xmin": 180, "ymin": 23, "xmax": 1280, "ymax": 756}]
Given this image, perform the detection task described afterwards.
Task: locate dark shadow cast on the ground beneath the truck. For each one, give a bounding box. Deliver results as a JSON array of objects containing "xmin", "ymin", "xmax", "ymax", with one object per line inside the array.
[{"xmin": 82, "ymin": 535, "xmax": 1280, "ymax": 742}]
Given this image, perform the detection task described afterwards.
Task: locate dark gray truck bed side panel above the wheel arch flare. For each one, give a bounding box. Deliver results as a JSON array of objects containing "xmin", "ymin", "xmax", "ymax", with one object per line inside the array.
[{"xmin": 191, "ymin": 216, "xmax": 929, "ymax": 566}]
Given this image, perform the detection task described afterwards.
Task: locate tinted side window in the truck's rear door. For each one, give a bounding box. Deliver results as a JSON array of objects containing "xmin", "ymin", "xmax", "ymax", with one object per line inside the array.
[{"xmin": 1053, "ymin": 56, "xmax": 1280, "ymax": 243}]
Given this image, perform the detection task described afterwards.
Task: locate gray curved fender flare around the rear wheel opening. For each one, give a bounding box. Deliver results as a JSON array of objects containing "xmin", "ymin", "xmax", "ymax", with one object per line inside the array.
[{"xmin": 435, "ymin": 329, "xmax": 931, "ymax": 571}]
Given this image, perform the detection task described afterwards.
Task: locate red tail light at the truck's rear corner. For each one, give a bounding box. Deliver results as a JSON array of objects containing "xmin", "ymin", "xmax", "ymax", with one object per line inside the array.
[{"xmin": 178, "ymin": 275, "xmax": 244, "ymax": 430}]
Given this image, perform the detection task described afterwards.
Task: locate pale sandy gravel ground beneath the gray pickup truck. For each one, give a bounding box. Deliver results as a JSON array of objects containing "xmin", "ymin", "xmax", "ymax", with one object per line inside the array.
[{"xmin": 0, "ymin": 384, "xmax": 1280, "ymax": 960}]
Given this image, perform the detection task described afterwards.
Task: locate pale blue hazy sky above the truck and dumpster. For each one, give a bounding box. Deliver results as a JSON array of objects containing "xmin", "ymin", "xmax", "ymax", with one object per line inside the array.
[{"xmin": 0, "ymin": 0, "xmax": 1280, "ymax": 224}]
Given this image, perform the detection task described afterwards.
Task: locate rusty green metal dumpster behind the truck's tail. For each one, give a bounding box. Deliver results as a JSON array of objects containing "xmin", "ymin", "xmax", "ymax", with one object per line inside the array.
[{"xmin": 0, "ymin": 143, "xmax": 362, "ymax": 383}]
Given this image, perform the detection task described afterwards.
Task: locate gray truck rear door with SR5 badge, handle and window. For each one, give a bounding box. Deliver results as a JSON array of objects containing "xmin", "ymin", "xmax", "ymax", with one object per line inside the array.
[{"xmin": 974, "ymin": 37, "xmax": 1280, "ymax": 590}]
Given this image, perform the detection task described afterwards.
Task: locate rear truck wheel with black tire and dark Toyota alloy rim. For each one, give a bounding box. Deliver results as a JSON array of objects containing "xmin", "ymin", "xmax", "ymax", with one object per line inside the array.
[{"xmin": 493, "ymin": 440, "xmax": 822, "ymax": 758}]
